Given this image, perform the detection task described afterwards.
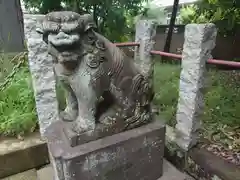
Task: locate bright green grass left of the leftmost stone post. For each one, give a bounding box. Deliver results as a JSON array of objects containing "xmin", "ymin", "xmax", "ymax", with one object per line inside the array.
[{"xmin": 0, "ymin": 59, "xmax": 37, "ymax": 136}]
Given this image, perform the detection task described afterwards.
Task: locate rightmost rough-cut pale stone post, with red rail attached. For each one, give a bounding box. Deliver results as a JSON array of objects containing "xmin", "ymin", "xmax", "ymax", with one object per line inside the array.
[{"xmin": 176, "ymin": 24, "xmax": 217, "ymax": 151}]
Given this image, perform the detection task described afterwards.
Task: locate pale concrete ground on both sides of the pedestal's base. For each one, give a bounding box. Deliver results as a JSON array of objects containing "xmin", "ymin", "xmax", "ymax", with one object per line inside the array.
[{"xmin": 1, "ymin": 160, "xmax": 194, "ymax": 180}]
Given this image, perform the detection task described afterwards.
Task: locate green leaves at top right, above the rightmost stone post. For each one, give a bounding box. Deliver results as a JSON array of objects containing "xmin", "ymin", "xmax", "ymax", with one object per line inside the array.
[{"xmin": 181, "ymin": 0, "xmax": 240, "ymax": 35}]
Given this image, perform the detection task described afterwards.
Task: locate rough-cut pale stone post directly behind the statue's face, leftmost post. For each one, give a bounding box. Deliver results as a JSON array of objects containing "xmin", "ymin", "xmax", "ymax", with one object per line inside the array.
[{"xmin": 24, "ymin": 14, "xmax": 58, "ymax": 137}]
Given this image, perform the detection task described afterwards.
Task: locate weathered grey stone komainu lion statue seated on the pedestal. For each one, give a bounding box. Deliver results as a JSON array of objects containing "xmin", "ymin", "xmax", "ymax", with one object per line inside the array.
[{"xmin": 38, "ymin": 11, "xmax": 153, "ymax": 133}]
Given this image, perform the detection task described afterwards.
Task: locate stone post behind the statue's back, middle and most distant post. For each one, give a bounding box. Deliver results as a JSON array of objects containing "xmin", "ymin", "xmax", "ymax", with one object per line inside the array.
[{"xmin": 134, "ymin": 20, "xmax": 156, "ymax": 76}]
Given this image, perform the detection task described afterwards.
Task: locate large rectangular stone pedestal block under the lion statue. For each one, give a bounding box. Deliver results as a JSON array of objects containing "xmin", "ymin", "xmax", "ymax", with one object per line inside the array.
[{"xmin": 46, "ymin": 121, "xmax": 165, "ymax": 180}]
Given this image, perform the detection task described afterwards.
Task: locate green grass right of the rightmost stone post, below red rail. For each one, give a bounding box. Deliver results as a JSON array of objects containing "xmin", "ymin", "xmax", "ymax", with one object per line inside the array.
[{"xmin": 204, "ymin": 70, "xmax": 240, "ymax": 126}]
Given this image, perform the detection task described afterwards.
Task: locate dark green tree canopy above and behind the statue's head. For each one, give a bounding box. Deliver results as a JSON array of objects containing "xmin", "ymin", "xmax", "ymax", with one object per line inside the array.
[{"xmin": 24, "ymin": 0, "xmax": 146, "ymax": 42}]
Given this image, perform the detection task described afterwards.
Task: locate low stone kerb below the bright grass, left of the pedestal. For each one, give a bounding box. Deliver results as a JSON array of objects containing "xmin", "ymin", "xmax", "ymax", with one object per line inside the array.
[{"xmin": 0, "ymin": 133, "xmax": 49, "ymax": 178}]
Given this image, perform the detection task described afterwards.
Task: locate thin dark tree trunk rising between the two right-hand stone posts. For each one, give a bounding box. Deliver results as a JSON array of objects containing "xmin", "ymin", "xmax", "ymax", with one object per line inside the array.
[{"xmin": 164, "ymin": 0, "xmax": 179, "ymax": 52}]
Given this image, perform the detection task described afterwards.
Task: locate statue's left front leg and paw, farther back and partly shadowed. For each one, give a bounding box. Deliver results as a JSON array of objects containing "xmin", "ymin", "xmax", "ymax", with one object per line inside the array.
[{"xmin": 60, "ymin": 82, "xmax": 78, "ymax": 122}]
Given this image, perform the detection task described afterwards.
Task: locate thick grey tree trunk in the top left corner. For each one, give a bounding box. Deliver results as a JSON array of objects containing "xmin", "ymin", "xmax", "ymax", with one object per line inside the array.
[{"xmin": 0, "ymin": 0, "xmax": 24, "ymax": 52}]
